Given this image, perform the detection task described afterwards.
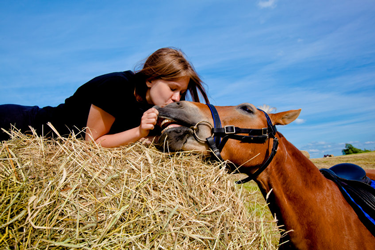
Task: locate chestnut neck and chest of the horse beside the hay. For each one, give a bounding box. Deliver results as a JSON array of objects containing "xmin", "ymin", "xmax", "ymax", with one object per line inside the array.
[{"xmin": 256, "ymin": 134, "xmax": 374, "ymax": 249}]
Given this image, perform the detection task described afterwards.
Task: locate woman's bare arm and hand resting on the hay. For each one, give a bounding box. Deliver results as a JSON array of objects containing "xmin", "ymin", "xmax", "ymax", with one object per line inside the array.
[{"xmin": 85, "ymin": 104, "xmax": 158, "ymax": 148}]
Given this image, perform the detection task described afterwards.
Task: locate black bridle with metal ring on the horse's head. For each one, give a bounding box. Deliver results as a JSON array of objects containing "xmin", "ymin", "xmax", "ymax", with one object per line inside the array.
[{"xmin": 193, "ymin": 104, "xmax": 279, "ymax": 184}]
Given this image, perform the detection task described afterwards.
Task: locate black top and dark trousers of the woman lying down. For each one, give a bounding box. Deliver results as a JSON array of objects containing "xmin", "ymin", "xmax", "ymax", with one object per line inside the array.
[{"xmin": 0, "ymin": 71, "xmax": 152, "ymax": 140}]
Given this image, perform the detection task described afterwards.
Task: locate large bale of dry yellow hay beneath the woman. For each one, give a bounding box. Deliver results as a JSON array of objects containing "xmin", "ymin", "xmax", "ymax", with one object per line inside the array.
[{"xmin": 0, "ymin": 132, "xmax": 277, "ymax": 249}]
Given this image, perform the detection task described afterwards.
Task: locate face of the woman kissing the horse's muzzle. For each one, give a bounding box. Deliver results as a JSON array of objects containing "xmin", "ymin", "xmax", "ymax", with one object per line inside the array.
[{"xmin": 146, "ymin": 76, "xmax": 190, "ymax": 107}]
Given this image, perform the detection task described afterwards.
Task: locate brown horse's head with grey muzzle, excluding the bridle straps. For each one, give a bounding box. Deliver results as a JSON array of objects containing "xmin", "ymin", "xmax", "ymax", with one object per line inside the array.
[{"xmin": 158, "ymin": 101, "xmax": 301, "ymax": 173}]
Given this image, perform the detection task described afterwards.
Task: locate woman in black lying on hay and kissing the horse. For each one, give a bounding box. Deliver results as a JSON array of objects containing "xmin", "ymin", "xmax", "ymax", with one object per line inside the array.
[{"xmin": 0, "ymin": 48, "xmax": 209, "ymax": 147}]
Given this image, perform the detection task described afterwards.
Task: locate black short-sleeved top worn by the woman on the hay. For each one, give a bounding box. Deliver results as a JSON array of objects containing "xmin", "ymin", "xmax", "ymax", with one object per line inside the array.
[{"xmin": 38, "ymin": 71, "xmax": 153, "ymax": 135}]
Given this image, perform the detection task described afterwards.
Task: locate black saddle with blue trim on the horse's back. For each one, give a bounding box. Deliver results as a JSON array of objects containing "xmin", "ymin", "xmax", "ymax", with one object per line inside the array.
[{"xmin": 320, "ymin": 163, "xmax": 375, "ymax": 236}]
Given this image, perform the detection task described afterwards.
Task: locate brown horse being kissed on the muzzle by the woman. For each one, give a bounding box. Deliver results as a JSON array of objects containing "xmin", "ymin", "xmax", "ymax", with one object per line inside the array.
[{"xmin": 158, "ymin": 101, "xmax": 375, "ymax": 250}]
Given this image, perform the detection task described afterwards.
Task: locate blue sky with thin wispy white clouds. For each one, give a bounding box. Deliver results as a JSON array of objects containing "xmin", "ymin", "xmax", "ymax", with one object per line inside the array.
[{"xmin": 0, "ymin": 0, "xmax": 375, "ymax": 158}]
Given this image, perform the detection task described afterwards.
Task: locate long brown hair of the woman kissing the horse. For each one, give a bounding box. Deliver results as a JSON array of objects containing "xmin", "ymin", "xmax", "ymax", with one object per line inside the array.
[{"xmin": 135, "ymin": 48, "xmax": 209, "ymax": 104}]
